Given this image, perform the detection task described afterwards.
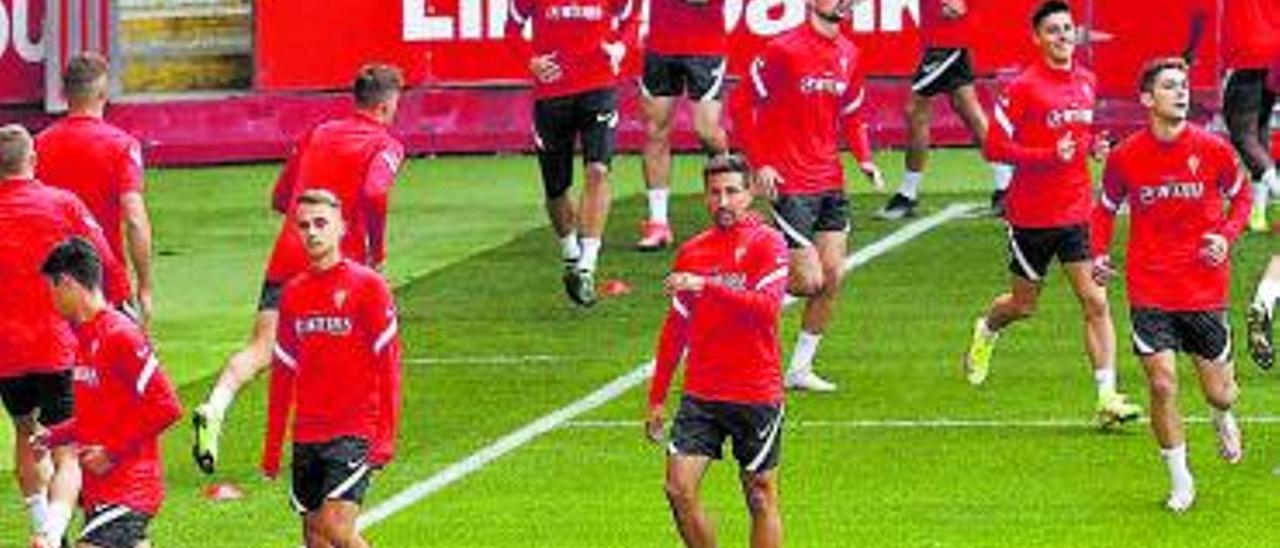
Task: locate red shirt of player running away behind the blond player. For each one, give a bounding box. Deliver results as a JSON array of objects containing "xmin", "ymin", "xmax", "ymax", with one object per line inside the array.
[{"xmin": 266, "ymin": 113, "xmax": 404, "ymax": 284}]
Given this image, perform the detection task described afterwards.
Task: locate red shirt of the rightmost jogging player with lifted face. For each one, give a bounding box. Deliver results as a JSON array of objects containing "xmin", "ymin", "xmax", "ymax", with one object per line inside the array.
[{"xmin": 1092, "ymin": 125, "xmax": 1251, "ymax": 311}]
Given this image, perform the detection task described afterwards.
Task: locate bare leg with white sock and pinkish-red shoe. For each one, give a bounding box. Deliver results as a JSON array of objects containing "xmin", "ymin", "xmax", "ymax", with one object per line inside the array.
[{"xmin": 636, "ymin": 96, "xmax": 676, "ymax": 251}]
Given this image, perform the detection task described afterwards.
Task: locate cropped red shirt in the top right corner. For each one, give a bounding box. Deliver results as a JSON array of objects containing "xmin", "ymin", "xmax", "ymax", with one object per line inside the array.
[{"xmin": 1221, "ymin": 0, "xmax": 1280, "ymax": 70}]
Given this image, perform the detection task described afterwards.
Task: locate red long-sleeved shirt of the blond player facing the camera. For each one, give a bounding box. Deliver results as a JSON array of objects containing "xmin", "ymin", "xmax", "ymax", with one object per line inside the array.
[{"xmin": 262, "ymin": 260, "xmax": 401, "ymax": 475}]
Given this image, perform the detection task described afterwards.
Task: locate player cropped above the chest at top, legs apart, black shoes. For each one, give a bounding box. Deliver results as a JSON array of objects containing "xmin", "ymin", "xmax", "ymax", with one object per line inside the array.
[{"xmin": 877, "ymin": 0, "xmax": 1012, "ymax": 219}]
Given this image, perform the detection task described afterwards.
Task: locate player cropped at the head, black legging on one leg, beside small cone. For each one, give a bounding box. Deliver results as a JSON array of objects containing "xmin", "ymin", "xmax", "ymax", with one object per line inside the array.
[{"xmin": 506, "ymin": 0, "xmax": 639, "ymax": 306}]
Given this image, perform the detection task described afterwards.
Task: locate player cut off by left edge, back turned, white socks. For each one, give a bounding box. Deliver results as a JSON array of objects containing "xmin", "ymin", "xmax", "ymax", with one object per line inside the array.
[{"xmin": 0, "ymin": 124, "xmax": 128, "ymax": 544}]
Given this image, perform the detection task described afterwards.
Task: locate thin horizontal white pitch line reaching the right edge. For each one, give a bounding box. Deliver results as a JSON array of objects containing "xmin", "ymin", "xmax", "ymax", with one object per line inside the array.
[{"xmin": 561, "ymin": 415, "xmax": 1280, "ymax": 430}]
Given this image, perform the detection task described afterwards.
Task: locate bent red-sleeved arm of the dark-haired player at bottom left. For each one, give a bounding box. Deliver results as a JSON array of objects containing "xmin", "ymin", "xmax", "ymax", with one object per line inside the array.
[{"xmin": 102, "ymin": 332, "xmax": 182, "ymax": 462}]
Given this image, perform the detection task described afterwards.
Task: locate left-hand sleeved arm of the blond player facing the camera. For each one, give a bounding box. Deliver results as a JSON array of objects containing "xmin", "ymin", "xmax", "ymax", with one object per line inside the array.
[{"xmin": 259, "ymin": 294, "xmax": 298, "ymax": 478}]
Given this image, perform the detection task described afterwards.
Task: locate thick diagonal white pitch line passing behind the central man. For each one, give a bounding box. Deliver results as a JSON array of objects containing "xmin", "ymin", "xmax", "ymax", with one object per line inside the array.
[{"xmin": 356, "ymin": 204, "xmax": 978, "ymax": 530}]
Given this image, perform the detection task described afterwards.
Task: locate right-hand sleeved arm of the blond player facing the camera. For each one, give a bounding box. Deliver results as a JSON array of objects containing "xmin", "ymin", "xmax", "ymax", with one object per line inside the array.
[{"xmin": 365, "ymin": 283, "xmax": 402, "ymax": 466}]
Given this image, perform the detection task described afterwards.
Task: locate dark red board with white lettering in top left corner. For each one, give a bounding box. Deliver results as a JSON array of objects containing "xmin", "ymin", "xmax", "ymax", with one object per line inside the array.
[{"xmin": 0, "ymin": 0, "xmax": 45, "ymax": 104}]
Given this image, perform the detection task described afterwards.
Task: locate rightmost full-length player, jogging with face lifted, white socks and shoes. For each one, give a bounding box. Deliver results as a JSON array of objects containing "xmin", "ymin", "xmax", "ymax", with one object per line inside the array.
[{"xmin": 1092, "ymin": 58, "xmax": 1249, "ymax": 512}]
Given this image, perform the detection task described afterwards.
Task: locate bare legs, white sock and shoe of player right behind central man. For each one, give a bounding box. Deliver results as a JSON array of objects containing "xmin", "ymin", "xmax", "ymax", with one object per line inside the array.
[{"xmin": 786, "ymin": 232, "xmax": 849, "ymax": 392}]
